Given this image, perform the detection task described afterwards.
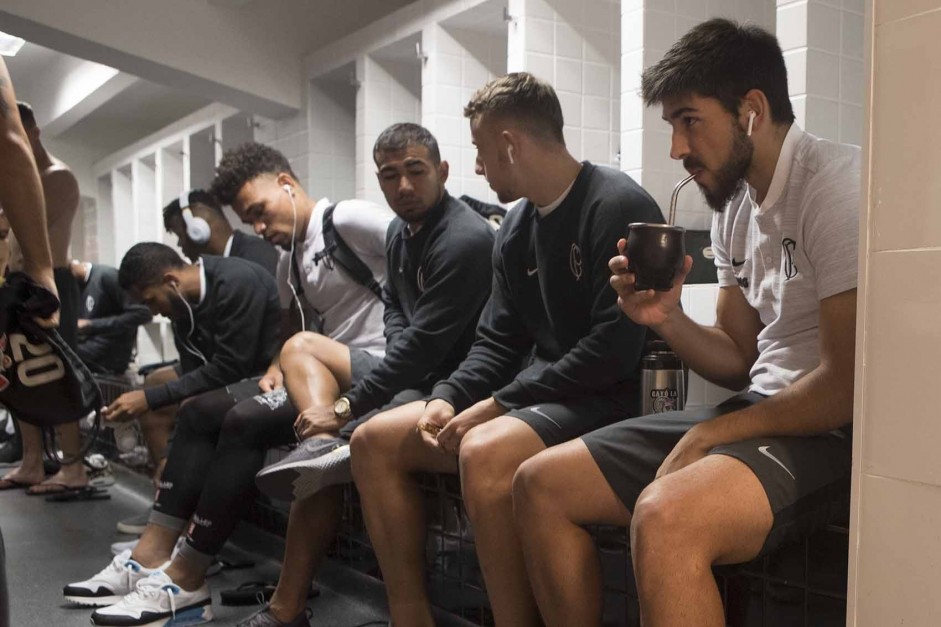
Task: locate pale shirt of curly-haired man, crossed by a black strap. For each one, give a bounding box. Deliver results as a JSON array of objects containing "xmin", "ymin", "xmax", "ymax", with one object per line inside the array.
[{"xmin": 278, "ymin": 198, "xmax": 395, "ymax": 357}]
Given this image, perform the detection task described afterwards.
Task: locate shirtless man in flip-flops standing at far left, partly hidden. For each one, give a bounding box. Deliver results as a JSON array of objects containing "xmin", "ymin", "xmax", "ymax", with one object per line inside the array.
[{"xmin": 0, "ymin": 102, "xmax": 88, "ymax": 494}]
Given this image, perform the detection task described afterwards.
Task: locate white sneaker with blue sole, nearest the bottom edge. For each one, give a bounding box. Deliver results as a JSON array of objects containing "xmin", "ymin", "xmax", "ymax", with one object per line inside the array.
[{"xmin": 91, "ymin": 570, "xmax": 212, "ymax": 627}]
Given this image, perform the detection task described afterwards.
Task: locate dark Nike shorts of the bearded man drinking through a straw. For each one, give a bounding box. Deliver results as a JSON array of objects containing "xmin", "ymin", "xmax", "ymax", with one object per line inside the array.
[{"xmin": 582, "ymin": 393, "xmax": 853, "ymax": 554}]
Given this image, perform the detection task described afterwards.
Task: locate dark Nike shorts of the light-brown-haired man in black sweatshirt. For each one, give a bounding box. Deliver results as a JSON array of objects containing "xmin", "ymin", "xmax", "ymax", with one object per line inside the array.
[{"xmin": 506, "ymin": 391, "xmax": 637, "ymax": 447}]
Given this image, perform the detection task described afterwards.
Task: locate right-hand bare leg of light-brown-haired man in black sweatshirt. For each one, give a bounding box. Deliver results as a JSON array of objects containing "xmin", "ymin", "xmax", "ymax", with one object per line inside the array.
[{"xmin": 460, "ymin": 416, "xmax": 546, "ymax": 627}]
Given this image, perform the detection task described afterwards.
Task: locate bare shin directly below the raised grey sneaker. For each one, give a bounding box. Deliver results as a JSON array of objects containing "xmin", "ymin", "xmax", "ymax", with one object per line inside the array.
[{"xmin": 271, "ymin": 486, "xmax": 343, "ymax": 623}]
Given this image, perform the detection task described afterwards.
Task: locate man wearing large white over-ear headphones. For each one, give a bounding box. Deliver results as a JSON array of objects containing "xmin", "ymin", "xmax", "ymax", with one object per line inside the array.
[{"xmin": 163, "ymin": 189, "xmax": 278, "ymax": 276}]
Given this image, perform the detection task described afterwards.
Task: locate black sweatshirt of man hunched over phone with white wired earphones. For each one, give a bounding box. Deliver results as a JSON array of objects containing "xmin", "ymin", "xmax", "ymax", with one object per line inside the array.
[{"xmin": 144, "ymin": 255, "xmax": 281, "ymax": 409}]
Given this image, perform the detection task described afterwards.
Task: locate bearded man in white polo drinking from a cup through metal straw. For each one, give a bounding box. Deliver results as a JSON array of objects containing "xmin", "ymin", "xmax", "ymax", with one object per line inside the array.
[{"xmin": 513, "ymin": 20, "xmax": 860, "ymax": 627}]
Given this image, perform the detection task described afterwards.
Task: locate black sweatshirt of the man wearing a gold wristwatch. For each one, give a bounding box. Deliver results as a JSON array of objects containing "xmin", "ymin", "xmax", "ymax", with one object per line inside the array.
[{"xmin": 344, "ymin": 192, "xmax": 494, "ymax": 416}]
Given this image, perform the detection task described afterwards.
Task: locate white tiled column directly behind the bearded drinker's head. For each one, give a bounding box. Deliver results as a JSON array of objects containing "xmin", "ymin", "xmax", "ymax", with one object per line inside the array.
[{"xmin": 777, "ymin": 0, "xmax": 865, "ymax": 145}]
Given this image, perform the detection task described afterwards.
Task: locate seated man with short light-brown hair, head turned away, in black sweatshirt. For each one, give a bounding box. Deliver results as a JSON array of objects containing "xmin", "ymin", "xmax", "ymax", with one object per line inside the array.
[{"xmin": 351, "ymin": 73, "xmax": 662, "ymax": 627}]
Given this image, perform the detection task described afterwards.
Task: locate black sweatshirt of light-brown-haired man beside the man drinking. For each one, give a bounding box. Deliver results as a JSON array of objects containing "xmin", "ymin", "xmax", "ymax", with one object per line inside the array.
[{"xmin": 432, "ymin": 162, "xmax": 663, "ymax": 412}]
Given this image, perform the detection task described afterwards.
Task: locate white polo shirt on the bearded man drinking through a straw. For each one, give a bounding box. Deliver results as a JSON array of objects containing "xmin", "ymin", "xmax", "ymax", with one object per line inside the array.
[{"xmin": 712, "ymin": 124, "xmax": 861, "ymax": 395}]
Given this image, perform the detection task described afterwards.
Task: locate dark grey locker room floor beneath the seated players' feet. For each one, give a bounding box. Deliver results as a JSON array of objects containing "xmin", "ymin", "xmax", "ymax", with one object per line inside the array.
[{"xmin": 0, "ymin": 469, "xmax": 478, "ymax": 627}]
